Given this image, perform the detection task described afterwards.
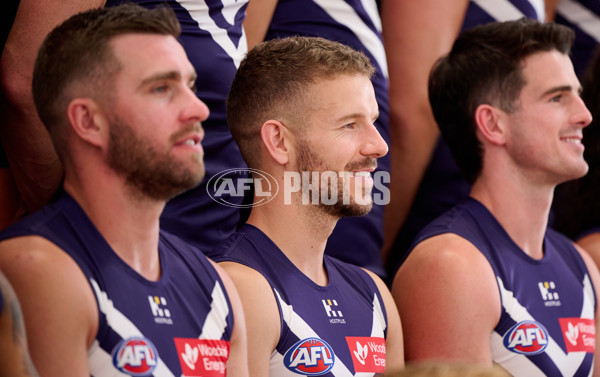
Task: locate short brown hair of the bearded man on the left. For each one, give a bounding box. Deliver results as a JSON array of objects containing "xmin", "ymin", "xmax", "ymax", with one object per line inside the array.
[{"xmin": 32, "ymin": 4, "xmax": 181, "ymax": 158}]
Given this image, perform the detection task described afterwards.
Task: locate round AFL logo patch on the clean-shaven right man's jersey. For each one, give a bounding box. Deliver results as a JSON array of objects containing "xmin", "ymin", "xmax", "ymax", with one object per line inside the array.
[{"xmin": 504, "ymin": 321, "xmax": 548, "ymax": 355}]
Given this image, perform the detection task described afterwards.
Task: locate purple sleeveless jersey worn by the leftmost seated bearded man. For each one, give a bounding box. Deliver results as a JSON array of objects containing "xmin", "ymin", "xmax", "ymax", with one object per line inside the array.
[{"xmin": 0, "ymin": 194, "xmax": 233, "ymax": 377}]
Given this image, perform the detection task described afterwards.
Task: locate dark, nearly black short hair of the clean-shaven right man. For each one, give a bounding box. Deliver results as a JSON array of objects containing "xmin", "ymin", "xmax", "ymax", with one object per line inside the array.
[{"xmin": 429, "ymin": 18, "xmax": 574, "ymax": 184}]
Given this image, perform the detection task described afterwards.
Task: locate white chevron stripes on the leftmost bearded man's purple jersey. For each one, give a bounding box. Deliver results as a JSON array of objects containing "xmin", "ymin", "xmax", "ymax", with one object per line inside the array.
[{"xmin": 88, "ymin": 279, "xmax": 229, "ymax": 377}]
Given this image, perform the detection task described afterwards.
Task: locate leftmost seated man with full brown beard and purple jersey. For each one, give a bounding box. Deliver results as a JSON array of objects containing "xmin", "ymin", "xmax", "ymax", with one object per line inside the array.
[{"xmin": 0, "ymin": 5, "xmax": 248, "ymax": 377}]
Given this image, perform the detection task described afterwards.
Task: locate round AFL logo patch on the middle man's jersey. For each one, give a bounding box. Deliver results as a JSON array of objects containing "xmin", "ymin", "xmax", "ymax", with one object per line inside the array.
[{"xmin": 283, "ymin": 338, "xmax": 335, "ymax": 376}]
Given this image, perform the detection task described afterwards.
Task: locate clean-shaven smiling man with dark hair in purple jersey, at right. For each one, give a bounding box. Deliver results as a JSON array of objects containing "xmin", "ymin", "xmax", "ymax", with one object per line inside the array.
[{"xmin": 392, "ymin": 19, "xmax": 600, "ymax": 377}]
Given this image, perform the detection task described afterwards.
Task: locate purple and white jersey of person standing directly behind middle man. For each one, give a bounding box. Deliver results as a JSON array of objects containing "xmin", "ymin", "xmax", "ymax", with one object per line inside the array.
[{"xmin": 266, "ymin": 0, "xmax": 390, "ymax": 277}]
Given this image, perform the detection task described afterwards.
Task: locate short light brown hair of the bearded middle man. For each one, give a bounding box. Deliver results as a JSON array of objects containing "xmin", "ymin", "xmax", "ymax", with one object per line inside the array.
[{"xmin": 227, "ymin": 37, "xmax": 375, "ymax": 167}]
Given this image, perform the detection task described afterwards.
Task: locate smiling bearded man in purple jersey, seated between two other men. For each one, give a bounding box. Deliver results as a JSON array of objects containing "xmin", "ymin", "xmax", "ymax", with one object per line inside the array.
[{"xmin": 213, "ymin": 37, "xmax": 404, "ymax": 377}]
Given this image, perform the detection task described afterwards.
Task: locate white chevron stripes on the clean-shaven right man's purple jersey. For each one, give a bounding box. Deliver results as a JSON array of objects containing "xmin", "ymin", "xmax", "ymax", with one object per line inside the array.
[{"xmin": 490, "ymin": 274, "xmax": 594, "ymax": 377}]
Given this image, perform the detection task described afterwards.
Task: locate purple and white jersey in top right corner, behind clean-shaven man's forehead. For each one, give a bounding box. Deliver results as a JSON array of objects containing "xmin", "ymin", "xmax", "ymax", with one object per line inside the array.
[{"xmin": 555, "ymin": 0, "xmax": 600, "ymax": 80}]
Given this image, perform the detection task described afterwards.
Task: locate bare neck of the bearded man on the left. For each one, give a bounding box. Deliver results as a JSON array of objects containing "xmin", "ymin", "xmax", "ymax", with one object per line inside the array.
[{"xmin": 64, "ymin": 178, "xmax": 165, "ymax": 281}]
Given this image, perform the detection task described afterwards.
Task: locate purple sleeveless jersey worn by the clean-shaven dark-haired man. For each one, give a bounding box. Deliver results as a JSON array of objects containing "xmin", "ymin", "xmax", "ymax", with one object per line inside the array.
[{"xmin": 408, "ymin": 198, "xmax": 597, "ymax": 377}]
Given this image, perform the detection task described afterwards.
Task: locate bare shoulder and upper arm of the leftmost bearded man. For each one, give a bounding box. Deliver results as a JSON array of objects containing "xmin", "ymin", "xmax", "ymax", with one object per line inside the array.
[{"xmin": 0, "ymin": 236, "xmax": 98, "ymax": 377}]
